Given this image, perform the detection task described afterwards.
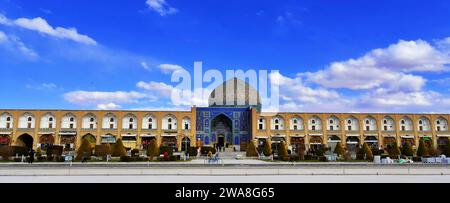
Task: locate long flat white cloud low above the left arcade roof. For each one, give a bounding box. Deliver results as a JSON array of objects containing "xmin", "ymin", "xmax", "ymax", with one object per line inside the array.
[{"xmin": 64, "ymin": 91, "xmax": 146, "ymax": 106}]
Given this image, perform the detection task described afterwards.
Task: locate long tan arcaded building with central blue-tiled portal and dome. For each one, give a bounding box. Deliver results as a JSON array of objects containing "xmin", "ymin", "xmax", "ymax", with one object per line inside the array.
[{"xmin": 0, "ymin": 79, "xmax": 450, "ymax": 152}]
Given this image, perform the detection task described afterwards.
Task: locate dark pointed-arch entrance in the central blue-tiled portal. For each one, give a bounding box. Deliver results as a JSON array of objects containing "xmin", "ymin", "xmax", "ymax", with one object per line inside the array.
[{"xmin": 211, "ymin": 114, "xmax": 233, "ymax": 149}]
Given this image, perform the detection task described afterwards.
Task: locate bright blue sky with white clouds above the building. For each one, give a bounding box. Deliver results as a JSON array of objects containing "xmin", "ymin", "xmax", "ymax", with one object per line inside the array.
[{"xmin": 0, "ymin": 0, "xmax": 450, "ymax": 113}]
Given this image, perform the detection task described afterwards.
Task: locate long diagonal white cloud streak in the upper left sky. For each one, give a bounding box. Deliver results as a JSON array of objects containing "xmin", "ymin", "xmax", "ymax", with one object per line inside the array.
[{"xmin": 0, "ymin": 14, "xmax": 97, "ymax": 45}]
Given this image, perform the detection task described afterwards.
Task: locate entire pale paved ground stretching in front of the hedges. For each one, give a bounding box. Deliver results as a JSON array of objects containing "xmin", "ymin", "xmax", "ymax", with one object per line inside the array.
[{"xmin": 0, "ymin": 160, "xmax": 450, "ymax": 183}]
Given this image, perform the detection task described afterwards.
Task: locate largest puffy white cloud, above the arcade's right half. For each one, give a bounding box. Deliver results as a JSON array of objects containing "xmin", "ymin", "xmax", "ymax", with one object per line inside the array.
[{"xmin": 304, "ymin": 40, "xmax": 450, "ymax": 91}]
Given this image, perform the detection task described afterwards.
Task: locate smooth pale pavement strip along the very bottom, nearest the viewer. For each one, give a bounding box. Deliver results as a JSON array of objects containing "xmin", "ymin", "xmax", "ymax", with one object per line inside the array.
[{"xmin": 0, "ymin": 175, "xmax": 450, "ymax": 183}]
